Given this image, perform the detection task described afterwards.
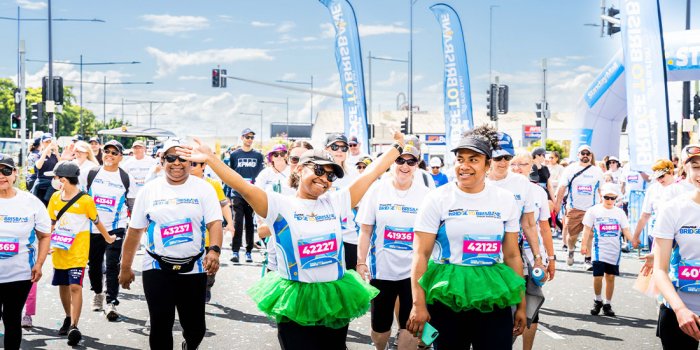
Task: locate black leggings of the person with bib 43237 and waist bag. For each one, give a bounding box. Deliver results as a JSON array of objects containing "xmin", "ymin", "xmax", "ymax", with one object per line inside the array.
[{"xmin": 143, "ymin": 270, "xmax": 207, "ymax": 350}]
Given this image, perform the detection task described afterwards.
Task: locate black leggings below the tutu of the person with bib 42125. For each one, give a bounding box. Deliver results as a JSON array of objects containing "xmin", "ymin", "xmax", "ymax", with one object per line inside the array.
[{"xmin": 428, "ymin": 302, "xmax": 513, "ymax": 350}]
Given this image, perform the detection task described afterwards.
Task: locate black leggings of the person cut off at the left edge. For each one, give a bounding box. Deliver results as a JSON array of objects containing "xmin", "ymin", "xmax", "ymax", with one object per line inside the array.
[{"xmin": 0, "ymin": 280, "xmax": 32, "ymax": 350}]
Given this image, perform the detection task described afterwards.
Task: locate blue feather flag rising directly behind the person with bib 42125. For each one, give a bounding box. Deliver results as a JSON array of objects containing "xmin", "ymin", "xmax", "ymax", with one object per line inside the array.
[{"xmin": 430, "ymin": 3, "xmax": 474, "ymax": 157}]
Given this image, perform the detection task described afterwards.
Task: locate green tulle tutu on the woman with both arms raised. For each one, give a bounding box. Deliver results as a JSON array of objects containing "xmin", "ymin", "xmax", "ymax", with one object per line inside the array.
[{"xmin": 248, "ymin": 270, "xmax": 379, "ymax": 329}]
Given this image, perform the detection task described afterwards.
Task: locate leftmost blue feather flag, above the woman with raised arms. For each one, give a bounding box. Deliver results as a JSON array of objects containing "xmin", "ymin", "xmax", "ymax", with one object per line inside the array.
[{"xmin": 319, "ymin": 0, "xmax": 370, "ymax": 154}]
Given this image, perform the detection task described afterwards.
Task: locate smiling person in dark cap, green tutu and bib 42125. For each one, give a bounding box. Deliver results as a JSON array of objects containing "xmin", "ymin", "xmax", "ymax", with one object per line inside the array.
[{"xmin": 407, "ymin": 126, "xmax": 526, "ymax": 350}]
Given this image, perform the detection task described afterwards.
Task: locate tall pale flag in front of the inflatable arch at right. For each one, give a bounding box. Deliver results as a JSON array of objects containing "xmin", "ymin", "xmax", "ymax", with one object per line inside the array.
[{"xmin": 620, "ymin": 0, "xmax": 670, "ymax": 172}]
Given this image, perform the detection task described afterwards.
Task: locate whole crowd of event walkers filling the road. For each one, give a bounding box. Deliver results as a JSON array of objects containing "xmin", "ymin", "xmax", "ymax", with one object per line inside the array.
[{"xmin": 0, "ymin": 126, "xmax": 700, "ymax": 350}]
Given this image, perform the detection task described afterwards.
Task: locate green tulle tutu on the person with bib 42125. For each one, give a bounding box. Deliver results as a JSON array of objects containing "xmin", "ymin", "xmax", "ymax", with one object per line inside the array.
[{"xmin": 418, "ymin": 261, "xmax": 525, "ymax": 312}]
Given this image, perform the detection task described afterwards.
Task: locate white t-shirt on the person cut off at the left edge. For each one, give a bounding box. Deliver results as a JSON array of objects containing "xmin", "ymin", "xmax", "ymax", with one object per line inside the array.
[{"xmin": 0, "ymin": 190, "xmax": 51, "ymax": 283}]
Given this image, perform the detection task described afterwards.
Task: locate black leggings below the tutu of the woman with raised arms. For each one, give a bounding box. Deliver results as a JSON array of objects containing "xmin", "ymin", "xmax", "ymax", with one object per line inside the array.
[{"xmin": 277, "ymin": 321, "xmax": 348, "ymax": 350}]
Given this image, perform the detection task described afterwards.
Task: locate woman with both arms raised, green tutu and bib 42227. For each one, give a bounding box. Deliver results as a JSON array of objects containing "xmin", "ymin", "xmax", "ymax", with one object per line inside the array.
[{"xmin": 180, "ymin": 132, "xmax": 404, "ymax": 350}]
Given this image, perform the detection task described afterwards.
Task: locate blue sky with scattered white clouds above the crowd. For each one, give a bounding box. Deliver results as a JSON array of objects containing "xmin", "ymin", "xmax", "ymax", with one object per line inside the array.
[{"xmin": 0, "ymin": 0, "xmax": 688, "ymax": 136}]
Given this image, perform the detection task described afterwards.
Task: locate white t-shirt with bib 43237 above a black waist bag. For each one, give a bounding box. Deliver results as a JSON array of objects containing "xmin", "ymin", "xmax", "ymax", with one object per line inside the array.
[{"xmin": 129, "ymin": 176, "xmax": 222, "ymax": 274}]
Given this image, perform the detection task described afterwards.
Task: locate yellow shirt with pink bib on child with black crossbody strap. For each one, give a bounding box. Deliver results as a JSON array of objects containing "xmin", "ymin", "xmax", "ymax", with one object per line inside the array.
[{"xmin": 47, "ymin": 191, "xmax": 97, "ymax": 270}]
